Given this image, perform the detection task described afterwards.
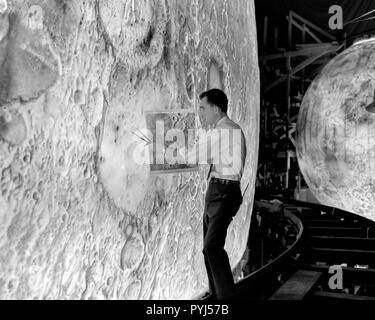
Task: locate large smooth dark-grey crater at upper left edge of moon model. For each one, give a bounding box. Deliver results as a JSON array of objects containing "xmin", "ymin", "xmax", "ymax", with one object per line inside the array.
[{"xmin": 0, "ymin": 12, "xmax": 59, "ymax": 106}]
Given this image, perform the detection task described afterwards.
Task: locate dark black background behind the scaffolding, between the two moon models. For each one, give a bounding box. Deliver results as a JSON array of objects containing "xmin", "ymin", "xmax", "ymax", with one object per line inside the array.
[{"xmin": 255, "ymin": 0, "xmax": 375, "ymax": 197}]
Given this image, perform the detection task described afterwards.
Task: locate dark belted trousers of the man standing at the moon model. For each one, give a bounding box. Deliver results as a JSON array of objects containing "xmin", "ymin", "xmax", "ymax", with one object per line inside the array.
[{"xmin": 203, "ymin": 180, "xmax": 242, "ymax": 300}]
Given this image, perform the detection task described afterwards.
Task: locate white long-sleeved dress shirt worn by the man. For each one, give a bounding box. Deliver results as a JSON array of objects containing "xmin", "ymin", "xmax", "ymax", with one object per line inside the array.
[{"xmin": 179, "ymin": 116, "xmax": 246, "ymax": 181}]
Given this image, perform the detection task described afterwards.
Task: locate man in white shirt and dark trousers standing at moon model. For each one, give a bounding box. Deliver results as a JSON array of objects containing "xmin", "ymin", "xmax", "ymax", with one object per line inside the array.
[{"xmin": 181, "ymin": 89, "xmax": 246, "ymax": 300}]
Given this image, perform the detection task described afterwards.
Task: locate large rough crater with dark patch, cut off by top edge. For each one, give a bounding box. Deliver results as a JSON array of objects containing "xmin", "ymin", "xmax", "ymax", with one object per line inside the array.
[{"xmin": 98, "ymin": 0, "xmax": 168, "ymax": 71}]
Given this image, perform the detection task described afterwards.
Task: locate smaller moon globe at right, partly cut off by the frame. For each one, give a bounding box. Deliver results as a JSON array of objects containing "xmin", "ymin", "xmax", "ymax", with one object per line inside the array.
[{"xmin": 297, "ymin": 40, "xmax": 375, "ymax": 220}]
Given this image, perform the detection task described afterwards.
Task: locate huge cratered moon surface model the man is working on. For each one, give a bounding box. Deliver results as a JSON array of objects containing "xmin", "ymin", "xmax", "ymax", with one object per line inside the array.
[{"xmin": 0, "ymin": 0, "xmax": 259, "ymax": 299}]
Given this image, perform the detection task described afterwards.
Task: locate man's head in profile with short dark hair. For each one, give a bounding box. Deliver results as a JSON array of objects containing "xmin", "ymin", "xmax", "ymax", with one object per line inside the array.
[{"xmin": 199, "ymin": 89, "xmax": 228, "ymax": 126}]
